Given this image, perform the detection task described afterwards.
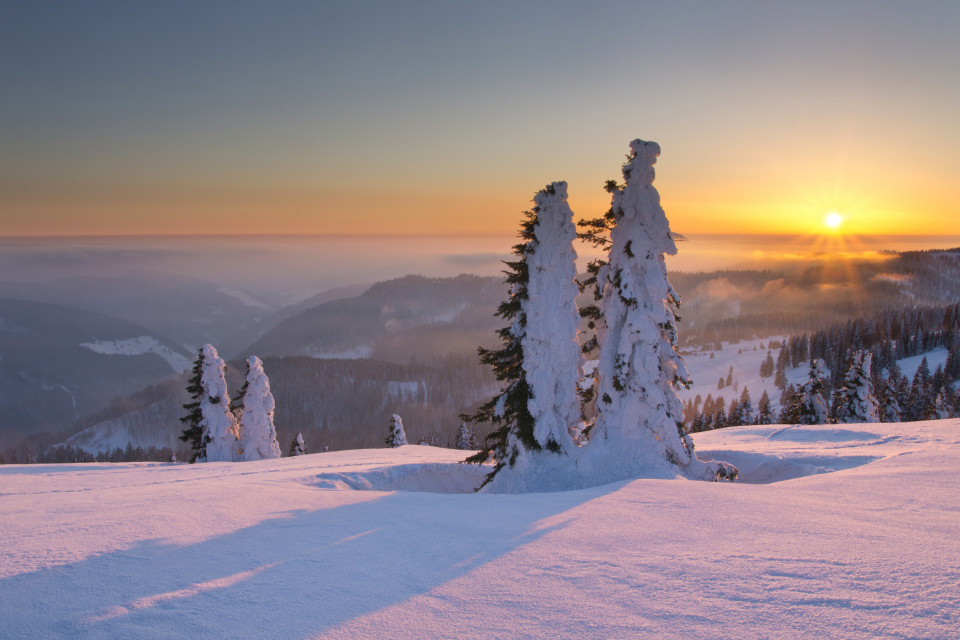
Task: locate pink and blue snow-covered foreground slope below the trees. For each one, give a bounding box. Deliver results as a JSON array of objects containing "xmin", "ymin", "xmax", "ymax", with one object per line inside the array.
[{"xmin": 0, "ymin": 420, "xmax": 960, "ymax": 640}]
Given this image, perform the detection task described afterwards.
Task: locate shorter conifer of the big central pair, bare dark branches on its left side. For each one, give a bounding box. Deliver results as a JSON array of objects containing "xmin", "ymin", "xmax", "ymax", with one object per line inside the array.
[{"xmin": 466, "ymin": 182, "xmax": 583, "ymax": 491}]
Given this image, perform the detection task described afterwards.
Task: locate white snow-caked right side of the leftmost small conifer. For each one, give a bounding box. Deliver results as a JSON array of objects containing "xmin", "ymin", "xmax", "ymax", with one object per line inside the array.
[{"xmin": 200, "ymin": 344, "xmax": 240, "ymax": 462}]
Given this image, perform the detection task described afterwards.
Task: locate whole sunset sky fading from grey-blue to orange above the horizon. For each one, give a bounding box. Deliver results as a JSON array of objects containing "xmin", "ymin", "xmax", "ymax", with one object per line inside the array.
[{"xmin": 0, "ymin": 0, "xmax": 960, "ymax": 236}]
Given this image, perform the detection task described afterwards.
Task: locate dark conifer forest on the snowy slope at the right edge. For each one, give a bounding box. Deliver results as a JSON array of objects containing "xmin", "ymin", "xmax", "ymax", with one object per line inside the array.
[{"xmin": 684, "ymin": 304, "xmax": 960, "ymax": 432}]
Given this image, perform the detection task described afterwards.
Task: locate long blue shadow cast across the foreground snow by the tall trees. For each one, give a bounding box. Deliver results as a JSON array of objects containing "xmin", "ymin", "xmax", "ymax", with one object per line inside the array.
[{"xmin": 0, "ymin": 483, "xmax": 623, "ymax": 638}]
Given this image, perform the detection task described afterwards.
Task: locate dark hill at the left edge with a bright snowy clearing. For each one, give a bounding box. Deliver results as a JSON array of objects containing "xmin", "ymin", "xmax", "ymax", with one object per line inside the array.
[{"xmin": 0, "ymin": 299, "xmax": 193, "ymax": 438}]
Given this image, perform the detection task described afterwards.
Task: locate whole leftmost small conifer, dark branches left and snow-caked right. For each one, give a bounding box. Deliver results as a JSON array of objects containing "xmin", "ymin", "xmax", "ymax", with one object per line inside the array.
[{"xmin": 180, "ymin": 344, "xmax": 239, "ymax": 462}]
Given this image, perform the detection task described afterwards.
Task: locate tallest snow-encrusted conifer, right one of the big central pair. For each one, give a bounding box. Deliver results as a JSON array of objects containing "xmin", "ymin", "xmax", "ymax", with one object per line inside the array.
[{"xmin": 590, "ymin": 140, "xmax": 737, "ymax": 479}]
